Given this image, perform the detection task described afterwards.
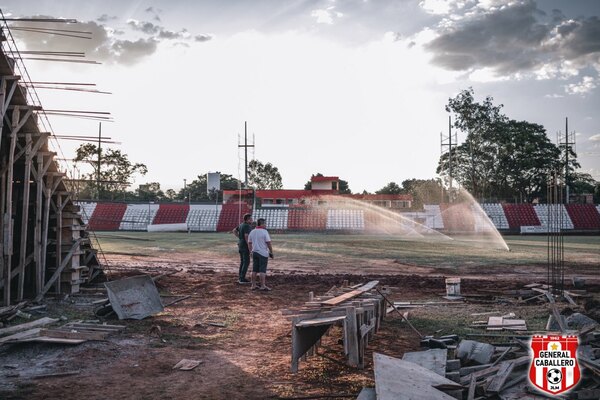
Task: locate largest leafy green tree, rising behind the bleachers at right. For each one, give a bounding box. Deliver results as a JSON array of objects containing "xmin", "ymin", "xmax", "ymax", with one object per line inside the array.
[{"xmin": 437, "ymin": 88, "xmax": 564, "ymax": 202}]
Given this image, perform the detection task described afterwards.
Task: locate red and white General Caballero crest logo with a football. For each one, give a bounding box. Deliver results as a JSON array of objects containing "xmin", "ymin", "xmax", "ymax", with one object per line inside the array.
[{"xmin": 529, "ymin": 336, "xmax": 581, "ymax": 394}]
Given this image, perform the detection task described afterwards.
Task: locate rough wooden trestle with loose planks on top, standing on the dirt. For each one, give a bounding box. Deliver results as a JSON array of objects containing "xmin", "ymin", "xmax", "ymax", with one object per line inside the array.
[{"xmin": 282, "ymin": 281, "xmax": 386, "ymax": 372}]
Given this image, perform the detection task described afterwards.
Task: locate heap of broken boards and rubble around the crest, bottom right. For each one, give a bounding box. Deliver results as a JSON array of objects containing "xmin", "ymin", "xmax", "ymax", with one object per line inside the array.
[{"xmin": 358, "ymin": 327, "xmax": 600, "ymax": 400}]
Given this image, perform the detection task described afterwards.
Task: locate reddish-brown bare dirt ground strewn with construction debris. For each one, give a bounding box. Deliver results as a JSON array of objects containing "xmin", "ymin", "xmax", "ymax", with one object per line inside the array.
[{"xmin": 0, "ymin": 234, "xmax": 600, "ymax": 400}]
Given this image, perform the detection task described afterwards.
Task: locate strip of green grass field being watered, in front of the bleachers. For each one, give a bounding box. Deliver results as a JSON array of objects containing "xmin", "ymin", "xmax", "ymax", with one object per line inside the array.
[{"xmin": 97, "ymin": 232, "xmax": 600, "ymax": 272}]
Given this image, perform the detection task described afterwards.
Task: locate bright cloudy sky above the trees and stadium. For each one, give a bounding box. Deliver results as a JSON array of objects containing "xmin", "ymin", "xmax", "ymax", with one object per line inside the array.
[{"xmin": 0, "ymin": 0, "xmax": 600, "ymax": 192}]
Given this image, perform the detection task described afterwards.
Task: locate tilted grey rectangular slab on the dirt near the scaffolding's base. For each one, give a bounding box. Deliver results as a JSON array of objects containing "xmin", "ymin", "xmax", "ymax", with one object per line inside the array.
[{"xmin": 104, "ymin": 275, "xmax": 164, "ymax": 319}]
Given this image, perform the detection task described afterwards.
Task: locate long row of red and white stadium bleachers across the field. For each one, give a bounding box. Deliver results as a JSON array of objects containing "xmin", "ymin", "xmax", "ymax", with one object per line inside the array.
[{"xmin": 78, "ymin": 202, "xmax": 600, "ymax": 232}]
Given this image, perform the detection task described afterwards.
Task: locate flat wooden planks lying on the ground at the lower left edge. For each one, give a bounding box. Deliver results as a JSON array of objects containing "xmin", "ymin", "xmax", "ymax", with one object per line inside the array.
[{"xmin": 0, "ymin": 317, "xmax": 125, "ymax": 345}]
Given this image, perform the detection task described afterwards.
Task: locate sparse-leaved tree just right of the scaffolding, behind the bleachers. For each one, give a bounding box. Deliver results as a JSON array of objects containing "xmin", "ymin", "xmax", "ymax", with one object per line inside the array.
[{"xmin": 74, "ymin": 143, "xmax": 148, "ymax": 200}]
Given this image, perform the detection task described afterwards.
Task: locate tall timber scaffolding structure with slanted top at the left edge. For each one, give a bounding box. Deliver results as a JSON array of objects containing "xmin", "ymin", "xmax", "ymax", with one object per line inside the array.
[{"xmin": 0, "ymin": 11, "xmax": 101, "ymax": 306}]
